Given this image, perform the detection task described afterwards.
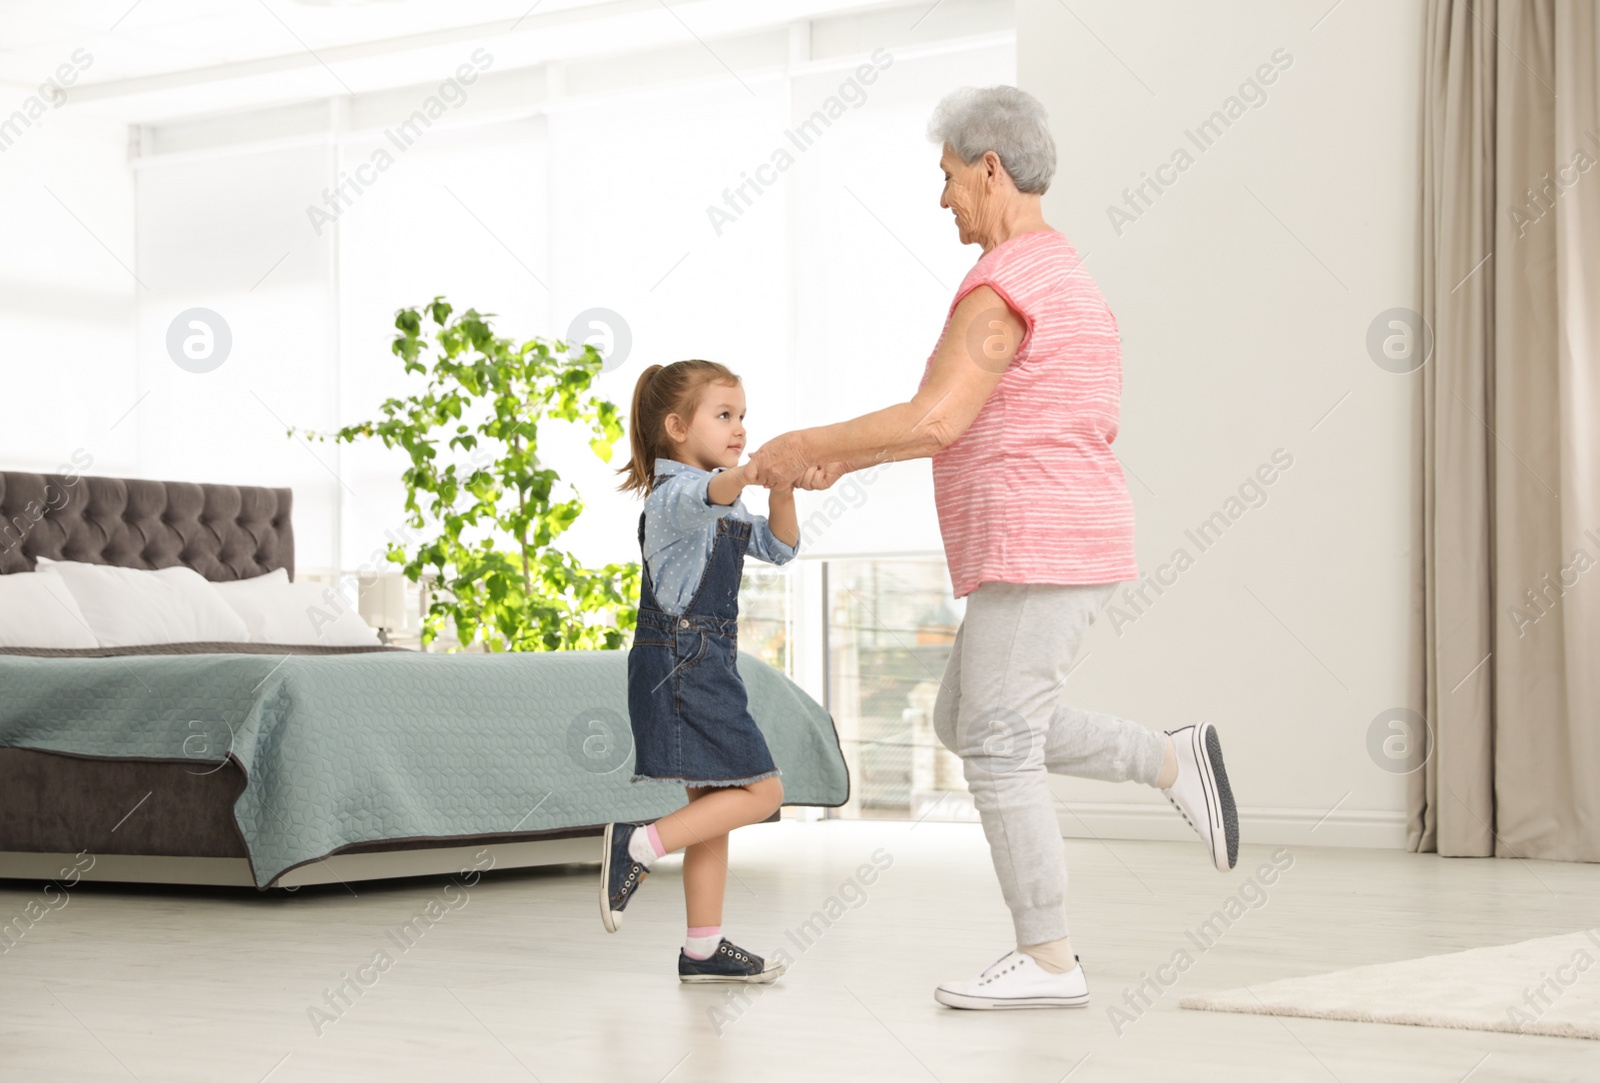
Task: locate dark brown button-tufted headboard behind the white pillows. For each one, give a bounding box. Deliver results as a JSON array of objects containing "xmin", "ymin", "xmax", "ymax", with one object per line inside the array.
[{"xmin": 0, "ymin": 470, "xmax": 294, "ymax": 582}]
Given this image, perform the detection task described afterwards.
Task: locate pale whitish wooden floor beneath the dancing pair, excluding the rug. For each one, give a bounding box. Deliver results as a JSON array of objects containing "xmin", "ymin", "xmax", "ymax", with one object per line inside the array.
[{"xmin": 0, "ymin": 821, "xmax": 1600, "ymax": 1083}]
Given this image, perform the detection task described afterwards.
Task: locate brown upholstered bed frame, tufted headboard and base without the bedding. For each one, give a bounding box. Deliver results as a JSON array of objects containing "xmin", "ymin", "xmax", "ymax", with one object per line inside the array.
[{"xmin": 0, "ymin": 472, "xmax": 605, "ymax": 888}]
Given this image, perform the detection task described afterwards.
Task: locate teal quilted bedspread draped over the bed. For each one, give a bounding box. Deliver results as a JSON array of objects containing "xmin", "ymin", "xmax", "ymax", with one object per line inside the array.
[{"xmin": 0, "ymin": 645, "xmax": 850, "ymax": 888}]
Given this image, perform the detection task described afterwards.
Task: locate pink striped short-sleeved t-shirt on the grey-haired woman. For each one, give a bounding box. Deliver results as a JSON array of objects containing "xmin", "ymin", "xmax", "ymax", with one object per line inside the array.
[{"xmin": 918, "ymin": 229, "xmax": 1139, "ymax": 598}]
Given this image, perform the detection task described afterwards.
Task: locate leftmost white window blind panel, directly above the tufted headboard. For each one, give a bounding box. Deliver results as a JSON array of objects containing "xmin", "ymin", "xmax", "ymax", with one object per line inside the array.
[{"xmin": 133, "ymin": 144, "xmax": 342, "ymax": 571}]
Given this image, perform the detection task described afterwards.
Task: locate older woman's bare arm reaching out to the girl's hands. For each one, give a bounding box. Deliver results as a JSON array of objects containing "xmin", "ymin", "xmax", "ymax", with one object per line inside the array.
[{"xmin": 747, "ymin": 286, "xmax": 1027, "ymax": 485}]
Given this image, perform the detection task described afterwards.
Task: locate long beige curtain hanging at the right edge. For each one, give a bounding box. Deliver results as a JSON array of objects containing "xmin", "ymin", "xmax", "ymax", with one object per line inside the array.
[{"xmin": 1408, "ymin": 0, "xmax": 1600, "ymax": 861}]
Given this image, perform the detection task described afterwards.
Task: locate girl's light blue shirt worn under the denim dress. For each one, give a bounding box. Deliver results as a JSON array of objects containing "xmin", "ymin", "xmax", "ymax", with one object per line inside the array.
[{"xmin": 645, "ymin": 459, "xmax": 800, "ymax": 616}]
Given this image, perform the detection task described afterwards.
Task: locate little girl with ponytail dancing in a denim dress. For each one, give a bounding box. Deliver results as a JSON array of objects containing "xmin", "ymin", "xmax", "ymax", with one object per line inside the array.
[{"xmin": 600, "ymin": 360, "xmax": 814, "ymax": 982}]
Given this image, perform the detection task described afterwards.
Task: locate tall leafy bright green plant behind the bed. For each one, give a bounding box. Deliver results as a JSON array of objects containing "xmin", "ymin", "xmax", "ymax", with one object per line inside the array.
[{"xmin": 305, "ymin": 296, "xmax": 642, "ymax": 653}]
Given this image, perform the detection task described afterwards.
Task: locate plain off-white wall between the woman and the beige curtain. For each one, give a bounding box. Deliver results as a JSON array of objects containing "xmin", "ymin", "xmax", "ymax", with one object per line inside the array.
[{"xmin": 1018, "ymin": 0, "xmax": 1422, "ymax": 846}]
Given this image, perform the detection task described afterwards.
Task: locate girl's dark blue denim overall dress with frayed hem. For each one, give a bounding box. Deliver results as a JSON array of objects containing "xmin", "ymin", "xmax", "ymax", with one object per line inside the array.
[{"xmin": 627, "ymin": 512, "xmax": 779, "ymax": 787}]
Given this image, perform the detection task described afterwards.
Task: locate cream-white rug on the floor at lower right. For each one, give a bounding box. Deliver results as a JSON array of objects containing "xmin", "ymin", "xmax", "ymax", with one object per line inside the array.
[{"xmin": 1178, "ymin": 929, "xmax": 1600, "ymax": 1041}]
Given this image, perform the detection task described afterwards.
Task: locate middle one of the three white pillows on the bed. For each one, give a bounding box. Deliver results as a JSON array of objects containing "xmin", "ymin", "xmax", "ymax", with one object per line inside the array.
[{"xmin": 38, "ymin": 557, "xmax": 250, "ymax": 646}]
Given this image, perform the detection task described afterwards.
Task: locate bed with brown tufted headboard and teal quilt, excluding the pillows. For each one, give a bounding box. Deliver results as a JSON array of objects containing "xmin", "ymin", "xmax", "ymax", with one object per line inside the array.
[{"xmin": 0, "ymin": 472, "xmax": 850, "ymax": 889}]
